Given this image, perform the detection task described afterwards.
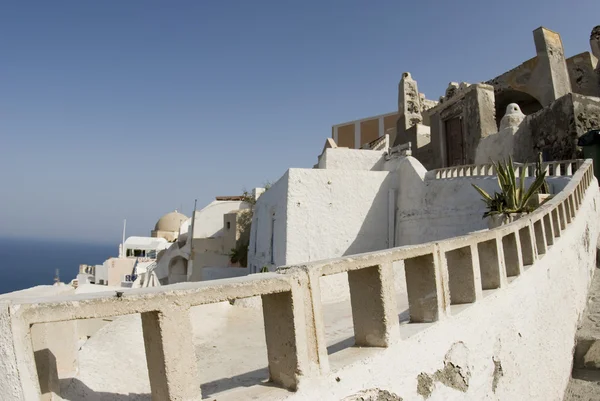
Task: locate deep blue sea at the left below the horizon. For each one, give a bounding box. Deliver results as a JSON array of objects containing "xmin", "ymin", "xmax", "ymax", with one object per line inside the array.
[{"xmin": 0, "ymin": 237, "xmax": 118, "ymax": 294}]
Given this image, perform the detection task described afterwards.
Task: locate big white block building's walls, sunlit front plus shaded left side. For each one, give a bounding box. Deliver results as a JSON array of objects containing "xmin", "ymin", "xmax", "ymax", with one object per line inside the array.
[{"xmin": 248, "ymin": 169, "xmax": 395, "ymax": 271}]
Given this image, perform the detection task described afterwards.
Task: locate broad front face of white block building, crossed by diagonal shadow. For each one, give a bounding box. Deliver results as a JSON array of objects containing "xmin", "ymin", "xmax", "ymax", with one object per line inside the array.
[{"xmin": 285, "ymin": 168, "xmax": 394, "ymax": 264}]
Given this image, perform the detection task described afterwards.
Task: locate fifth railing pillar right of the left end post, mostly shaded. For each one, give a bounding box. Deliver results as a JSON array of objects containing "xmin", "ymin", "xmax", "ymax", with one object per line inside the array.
[{"xmin": 445, "ymin": 246, "xmax": 482, "ymax": 305}]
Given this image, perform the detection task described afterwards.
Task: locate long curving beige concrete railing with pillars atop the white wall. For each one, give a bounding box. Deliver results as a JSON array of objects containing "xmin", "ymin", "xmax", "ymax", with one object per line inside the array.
[{"xmin": 0, "ymin": 160, "xmax": 595, "ymax": 400}]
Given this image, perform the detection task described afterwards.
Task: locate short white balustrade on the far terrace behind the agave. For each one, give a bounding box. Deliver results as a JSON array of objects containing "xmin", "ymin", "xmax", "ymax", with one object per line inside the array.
[{"xmin": 427, "ymin": 160, "xmax": 582, "ymax": 179}]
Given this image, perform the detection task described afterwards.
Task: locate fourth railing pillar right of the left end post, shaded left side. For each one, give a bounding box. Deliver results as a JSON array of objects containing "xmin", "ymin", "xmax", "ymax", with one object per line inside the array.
[{"xmin": 404, "ymin": 250, "xmax": 450, "ymax": 323}]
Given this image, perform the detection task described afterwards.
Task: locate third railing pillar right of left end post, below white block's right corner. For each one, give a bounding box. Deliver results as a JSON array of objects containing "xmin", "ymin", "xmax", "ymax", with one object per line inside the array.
[{"xmin": 348, "ymin": 263, "xmax": 398, "ymax": 347}]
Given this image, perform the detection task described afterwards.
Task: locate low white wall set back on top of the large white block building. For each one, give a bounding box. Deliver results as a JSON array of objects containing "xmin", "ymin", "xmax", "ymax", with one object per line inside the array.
[{"xmin": 319, "ymin": 148, "xmax": 384, "ymax": 171}]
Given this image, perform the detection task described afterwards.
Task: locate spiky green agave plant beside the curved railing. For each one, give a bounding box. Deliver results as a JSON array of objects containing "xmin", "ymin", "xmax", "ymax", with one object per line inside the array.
[{"xmin": 471, "ymin": 157, "xmax": 546, "ymax": 218}]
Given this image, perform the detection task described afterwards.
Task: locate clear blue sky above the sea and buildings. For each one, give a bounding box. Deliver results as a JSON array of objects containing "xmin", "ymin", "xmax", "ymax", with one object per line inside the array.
[{"xmin": 0, "ymin": 0, "xmax": 600, "ymax": 243}]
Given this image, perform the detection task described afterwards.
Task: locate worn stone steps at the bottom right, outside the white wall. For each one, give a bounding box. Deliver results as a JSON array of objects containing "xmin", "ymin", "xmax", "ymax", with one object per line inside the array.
[{"xmin": 564, "ymin": 260, "xmax": 600, "ymax": 401}]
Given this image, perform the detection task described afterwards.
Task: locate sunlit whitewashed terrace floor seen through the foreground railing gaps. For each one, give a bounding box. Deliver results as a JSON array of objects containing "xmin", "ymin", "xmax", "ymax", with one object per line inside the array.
[{"xmin": 56, "ymin": 276, "xmax": 412, "ymax": 401}]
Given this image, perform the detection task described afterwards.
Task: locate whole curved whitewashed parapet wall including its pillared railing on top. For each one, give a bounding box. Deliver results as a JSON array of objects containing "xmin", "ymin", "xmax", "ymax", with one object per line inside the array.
[{"xmin": 0, "ymin": 161, "xmax": 600, "ymax": 401}]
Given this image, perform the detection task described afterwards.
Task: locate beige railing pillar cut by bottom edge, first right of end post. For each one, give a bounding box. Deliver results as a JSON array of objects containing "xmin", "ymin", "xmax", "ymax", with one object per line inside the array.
[{"xmin": 141, "ymin": 308, "xmax": 202, "ymax": 401}]
